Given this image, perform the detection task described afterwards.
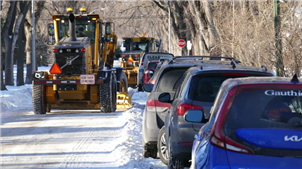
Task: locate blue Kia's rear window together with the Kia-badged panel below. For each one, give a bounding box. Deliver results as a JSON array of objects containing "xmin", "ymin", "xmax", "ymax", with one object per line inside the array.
[{"xmin": 224, "ymin": 90, "xmax": 302, "ymax": 157}]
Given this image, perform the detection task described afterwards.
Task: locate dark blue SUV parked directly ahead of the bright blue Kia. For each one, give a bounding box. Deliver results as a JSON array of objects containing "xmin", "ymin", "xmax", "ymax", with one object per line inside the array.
[{"xmin": 157, "ymin": 62, "xmax": 273, "ymax": 169}]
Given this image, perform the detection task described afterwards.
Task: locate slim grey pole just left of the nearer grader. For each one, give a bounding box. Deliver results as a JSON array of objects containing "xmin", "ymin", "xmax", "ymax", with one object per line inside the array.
[{"xmin": 31, "ymin": 0, "xmax": 36, "ymax": 72}]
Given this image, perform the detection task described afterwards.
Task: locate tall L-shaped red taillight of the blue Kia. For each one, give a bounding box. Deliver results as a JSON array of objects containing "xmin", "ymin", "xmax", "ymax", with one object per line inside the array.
[{"xmin": 211, "ymin": 87, "xmax": 255, "ymax": 154}]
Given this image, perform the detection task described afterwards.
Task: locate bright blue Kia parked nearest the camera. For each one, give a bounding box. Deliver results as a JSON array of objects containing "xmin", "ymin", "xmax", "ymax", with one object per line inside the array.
[{"xmin": 190, "ymin": 77, "xmax": 302, "ymax": 169}]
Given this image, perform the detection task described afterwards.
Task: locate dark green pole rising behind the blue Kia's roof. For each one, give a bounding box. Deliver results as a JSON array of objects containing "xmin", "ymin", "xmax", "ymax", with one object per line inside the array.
[{"xmin": 274, "ymin": 0, "xmax": 284, "ymax": 76}]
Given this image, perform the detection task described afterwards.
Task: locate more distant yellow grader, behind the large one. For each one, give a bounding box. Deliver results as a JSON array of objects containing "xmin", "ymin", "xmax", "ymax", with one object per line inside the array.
[{"xmin": 121, "ymin": 34, "xmax": 161, "ymax": 91}]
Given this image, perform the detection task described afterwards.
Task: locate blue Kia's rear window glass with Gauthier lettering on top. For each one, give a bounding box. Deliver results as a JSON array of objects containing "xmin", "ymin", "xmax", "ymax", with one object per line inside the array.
[{"xmin": 225, "ymin": 90, "xmax": 302, "ymax": 130}]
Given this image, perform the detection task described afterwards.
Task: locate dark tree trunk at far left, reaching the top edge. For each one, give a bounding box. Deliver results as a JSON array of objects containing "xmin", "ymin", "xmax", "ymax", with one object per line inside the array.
[{"xmin": 3, "ymin": 0, "xmax": 17, "ymax": 86}]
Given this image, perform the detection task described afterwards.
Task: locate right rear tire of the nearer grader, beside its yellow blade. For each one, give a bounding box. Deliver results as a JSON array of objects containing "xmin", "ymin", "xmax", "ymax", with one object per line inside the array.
[{"xmin": 99, "ymin": 73, "xmax": 116, "ymax": 113}]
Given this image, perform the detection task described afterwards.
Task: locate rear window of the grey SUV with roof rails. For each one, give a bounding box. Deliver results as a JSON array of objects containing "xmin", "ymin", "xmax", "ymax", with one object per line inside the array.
[{"xmin": 157, "ymin": 68, "xmax": 188, "ymax": 92}]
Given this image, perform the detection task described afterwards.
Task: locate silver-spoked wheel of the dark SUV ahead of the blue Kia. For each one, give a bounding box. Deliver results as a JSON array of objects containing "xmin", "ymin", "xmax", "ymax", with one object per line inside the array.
[{"xmin": 157, "ymin": 126, "xmax": 169, "ymax": 165}]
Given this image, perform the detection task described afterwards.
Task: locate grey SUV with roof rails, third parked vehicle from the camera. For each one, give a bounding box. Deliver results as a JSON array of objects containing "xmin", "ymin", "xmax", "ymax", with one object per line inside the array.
[{"xmin": 142, "ymin": 56, "xmax": 241, "ymax": 164}]
